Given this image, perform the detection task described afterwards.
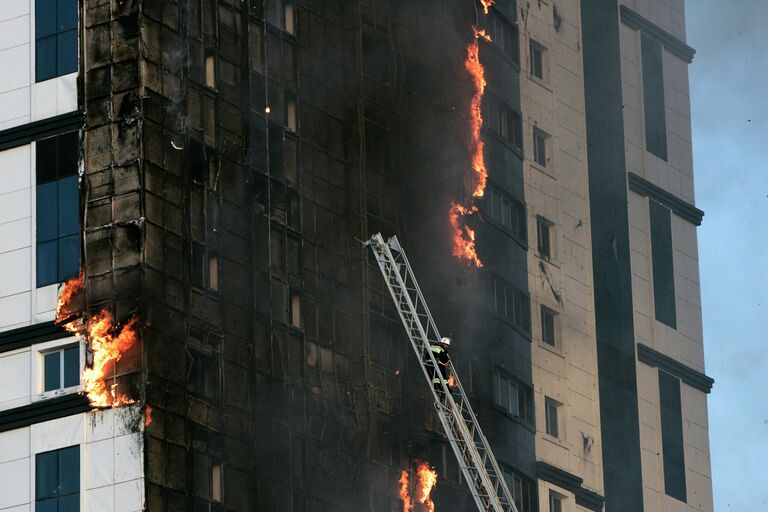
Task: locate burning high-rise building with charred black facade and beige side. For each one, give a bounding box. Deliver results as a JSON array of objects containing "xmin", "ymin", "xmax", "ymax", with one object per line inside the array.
[{"xmin": 0, "ymin": 0, "xmax": 712, "ymax": 512}]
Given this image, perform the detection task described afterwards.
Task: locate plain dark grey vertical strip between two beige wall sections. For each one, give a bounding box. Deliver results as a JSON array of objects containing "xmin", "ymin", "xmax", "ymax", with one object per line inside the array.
[{"xmin": 581, "ymin": 0, "xmax": 643, "ymax": 512}]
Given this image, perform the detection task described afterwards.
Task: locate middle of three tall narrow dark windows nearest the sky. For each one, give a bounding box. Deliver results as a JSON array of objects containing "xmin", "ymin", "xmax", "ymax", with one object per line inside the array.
[{"xmin": 648, "ymin": 199, "xmax": 677, "ymax": 329}]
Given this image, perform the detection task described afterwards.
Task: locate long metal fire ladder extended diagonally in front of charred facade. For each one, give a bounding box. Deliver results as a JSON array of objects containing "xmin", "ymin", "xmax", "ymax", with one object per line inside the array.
[{"xmin": 365, "ymin": 233, "xmax": 518, "ymax": 512}]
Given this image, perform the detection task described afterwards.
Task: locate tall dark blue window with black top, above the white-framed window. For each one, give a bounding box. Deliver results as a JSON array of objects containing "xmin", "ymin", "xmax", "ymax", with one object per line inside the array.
[{"xmin": 35, "ymin": 132, "xmax": 80, "ymax": 288}]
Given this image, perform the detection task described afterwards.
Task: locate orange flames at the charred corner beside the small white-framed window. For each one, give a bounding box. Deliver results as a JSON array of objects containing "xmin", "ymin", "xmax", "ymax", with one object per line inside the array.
[{"xmin": 56, "ymin": 273, "xmax": 139, "ymax": 412}]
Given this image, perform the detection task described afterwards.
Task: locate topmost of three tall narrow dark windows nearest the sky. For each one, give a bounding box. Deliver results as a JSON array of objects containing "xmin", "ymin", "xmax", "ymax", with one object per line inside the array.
[{"xmin": 640, "ymin": 34, "xmax": 667, "ymax": 160}]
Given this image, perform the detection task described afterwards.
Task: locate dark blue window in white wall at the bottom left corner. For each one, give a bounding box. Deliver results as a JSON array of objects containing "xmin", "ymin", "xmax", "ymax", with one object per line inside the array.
[{"xmin": 35, "ymin": 445, "xmax": 80, "ymax": 512}]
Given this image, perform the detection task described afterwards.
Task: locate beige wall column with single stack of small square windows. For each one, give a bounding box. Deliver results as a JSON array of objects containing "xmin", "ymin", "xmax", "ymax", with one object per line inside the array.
[{"xmin": 520, "ymin": 2, "xmax": 603, "ymax": 512}]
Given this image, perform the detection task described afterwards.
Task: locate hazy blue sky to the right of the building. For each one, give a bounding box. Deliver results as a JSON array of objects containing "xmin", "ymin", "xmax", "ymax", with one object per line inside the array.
[{"xmin": 685, "ymin": 0, "xmax": 768, "ymax": 512}]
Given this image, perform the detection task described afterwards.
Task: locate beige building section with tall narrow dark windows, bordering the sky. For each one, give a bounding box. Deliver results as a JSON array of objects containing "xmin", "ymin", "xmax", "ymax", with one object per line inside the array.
[{"xmin": 619, "ymin": 1, "xmax": 713, "ymax": 510}]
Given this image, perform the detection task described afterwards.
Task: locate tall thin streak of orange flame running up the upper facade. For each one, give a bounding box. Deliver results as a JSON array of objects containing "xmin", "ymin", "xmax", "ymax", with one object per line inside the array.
[{"xmin": 449, "ymin": 16, "xmax": 493, "ymax": 268}]
